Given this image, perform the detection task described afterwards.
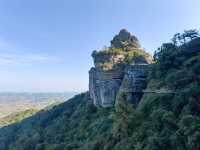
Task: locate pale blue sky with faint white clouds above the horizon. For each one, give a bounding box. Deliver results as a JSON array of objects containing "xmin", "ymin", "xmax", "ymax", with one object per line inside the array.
[{"xmin": 0, "ymin": 0, "xmax": 200, "ymax": 92}]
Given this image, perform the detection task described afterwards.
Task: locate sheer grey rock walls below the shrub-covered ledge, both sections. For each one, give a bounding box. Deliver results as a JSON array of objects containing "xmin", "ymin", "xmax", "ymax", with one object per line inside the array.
[{"xmin": 89, "ymin": 64, "xmax": 148, "ymax": 107}]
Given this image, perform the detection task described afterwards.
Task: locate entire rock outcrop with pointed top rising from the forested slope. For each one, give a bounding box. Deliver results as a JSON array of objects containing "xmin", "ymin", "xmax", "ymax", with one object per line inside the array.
[{"xmin": 89, "ymin": 29, "xmax": 152, "ymax": 107}]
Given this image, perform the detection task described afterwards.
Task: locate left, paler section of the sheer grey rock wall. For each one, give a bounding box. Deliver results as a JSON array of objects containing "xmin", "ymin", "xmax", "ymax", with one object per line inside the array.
[{"xmin": 89, "ymin": 68, "xmax": 124, "ymax": 107}]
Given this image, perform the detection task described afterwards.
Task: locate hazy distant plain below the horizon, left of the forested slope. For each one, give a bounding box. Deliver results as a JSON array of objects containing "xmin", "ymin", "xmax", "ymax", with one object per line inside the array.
[{"xmin": 0, "ymin": 92, "xmax": 76, "ymax": 120}]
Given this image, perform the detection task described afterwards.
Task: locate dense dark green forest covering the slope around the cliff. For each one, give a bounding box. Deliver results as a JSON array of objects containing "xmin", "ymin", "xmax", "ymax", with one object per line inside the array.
[{"xmin": 0, "ymin": 30, "xmax": 200, "ymax": 150}]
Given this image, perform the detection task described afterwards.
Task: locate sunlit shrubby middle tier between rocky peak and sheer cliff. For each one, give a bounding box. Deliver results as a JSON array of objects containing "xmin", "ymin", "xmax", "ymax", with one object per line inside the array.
[{"xmin": 92, "ymin": 47, "xmax": 152, "ymax": 70}]
